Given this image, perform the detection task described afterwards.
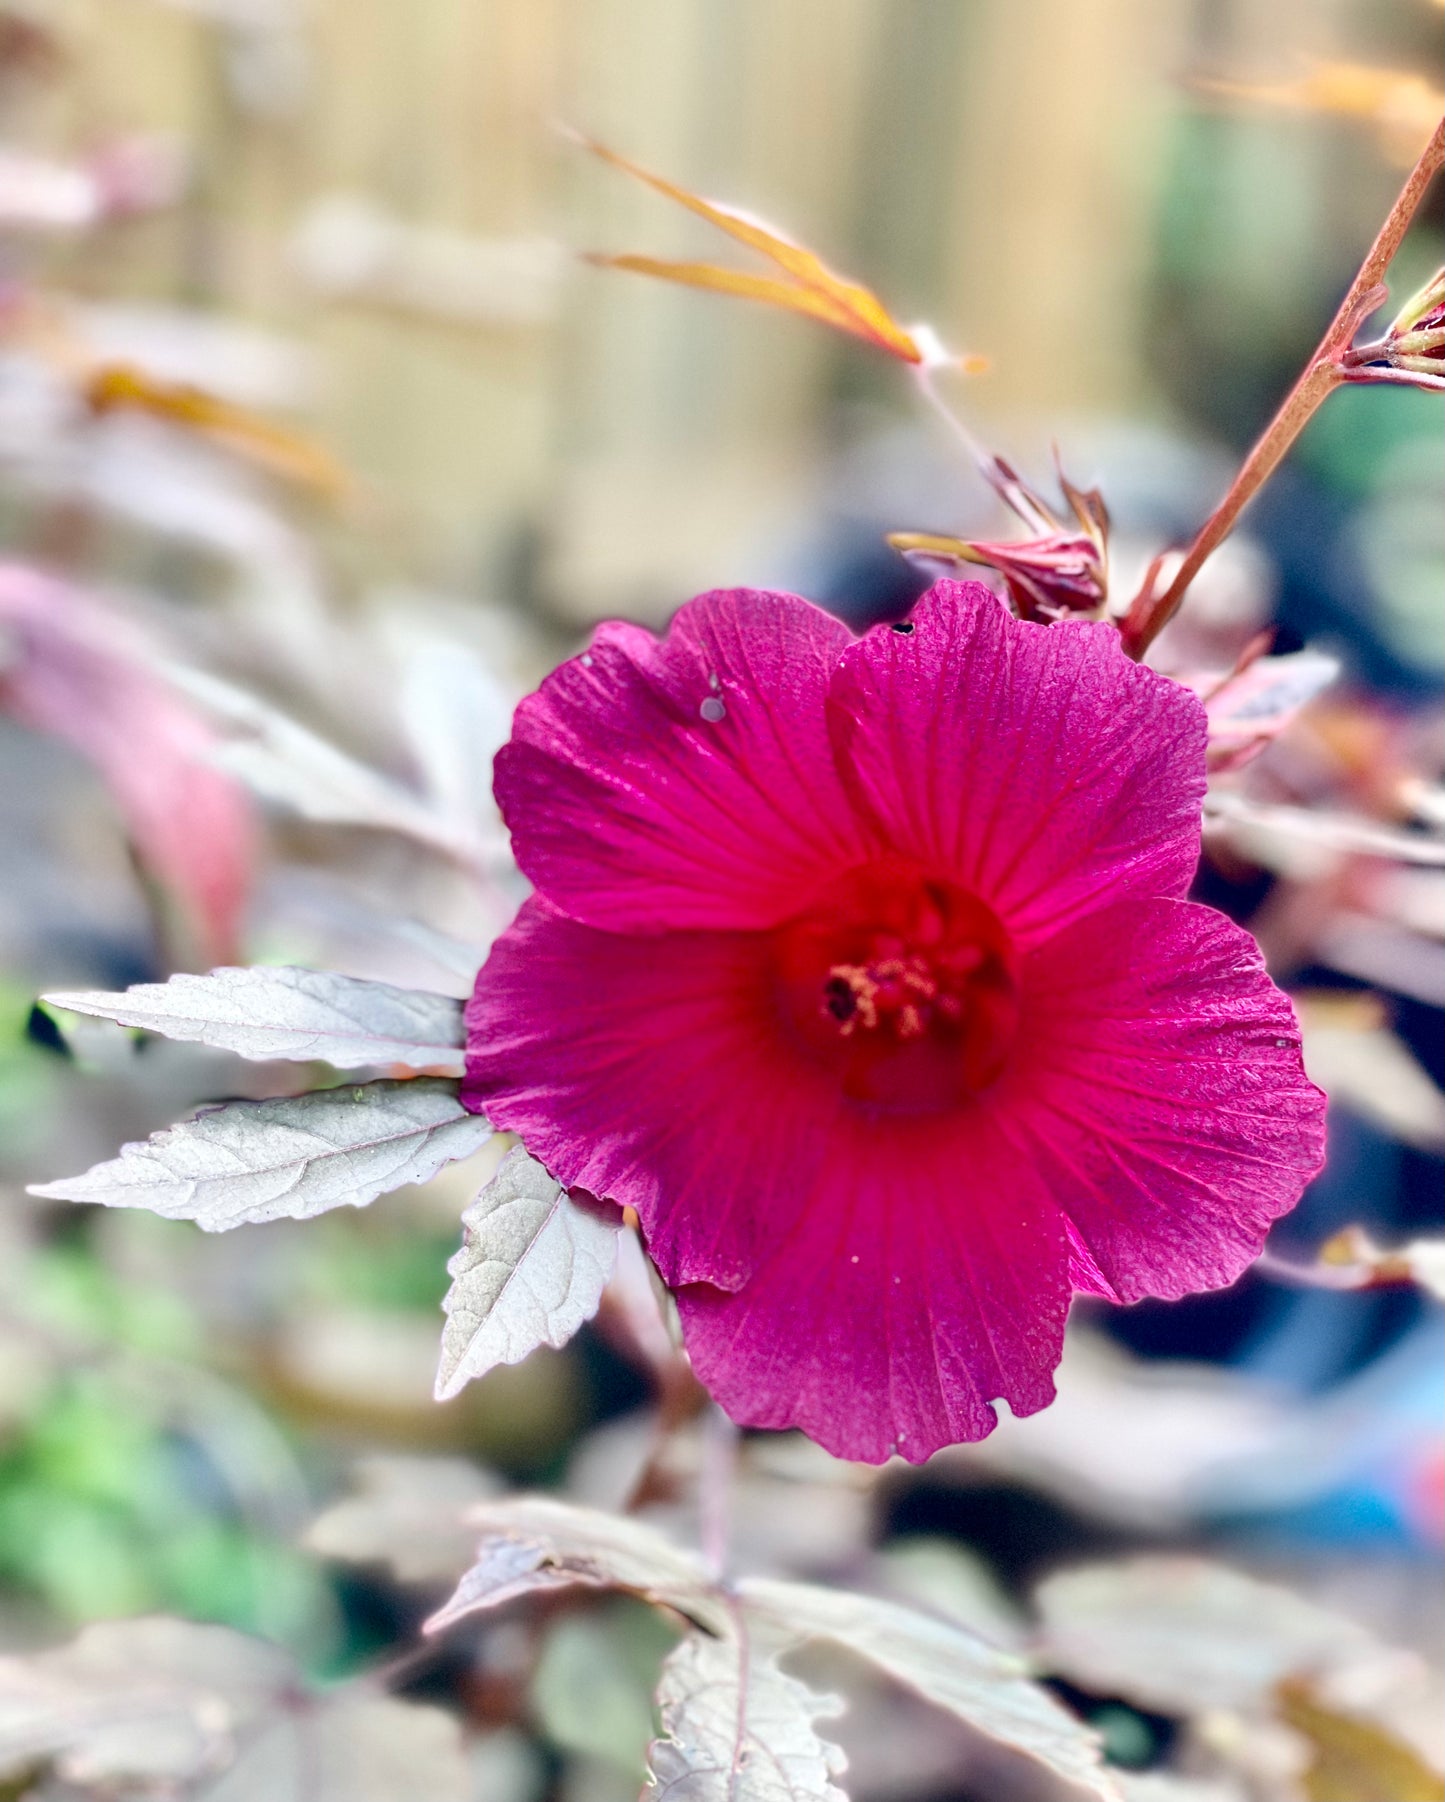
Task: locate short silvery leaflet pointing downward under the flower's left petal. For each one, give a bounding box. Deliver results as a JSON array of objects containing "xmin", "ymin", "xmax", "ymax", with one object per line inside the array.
[{"xmin": 436, "ymin": 1146, "xmax": 620, "ymax": 1402}]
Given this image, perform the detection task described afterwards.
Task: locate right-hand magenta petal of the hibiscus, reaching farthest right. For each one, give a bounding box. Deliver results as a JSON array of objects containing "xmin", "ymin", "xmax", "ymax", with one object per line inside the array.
[{"xmin": 996, "ymin": 901, "xmax": 1324, "ymax": 1301}]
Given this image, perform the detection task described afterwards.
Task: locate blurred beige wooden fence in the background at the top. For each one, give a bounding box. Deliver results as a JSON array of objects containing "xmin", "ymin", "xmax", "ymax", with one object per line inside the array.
[{"xmin": 27, "ymin": 0, "xmax": 1383, "ymax": 616}]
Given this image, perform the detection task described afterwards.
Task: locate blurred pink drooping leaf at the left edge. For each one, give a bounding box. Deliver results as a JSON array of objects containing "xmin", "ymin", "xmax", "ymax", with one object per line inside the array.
[{"xmin": 0, "ymin": 564, "xmax": 256, "ymax": 962}]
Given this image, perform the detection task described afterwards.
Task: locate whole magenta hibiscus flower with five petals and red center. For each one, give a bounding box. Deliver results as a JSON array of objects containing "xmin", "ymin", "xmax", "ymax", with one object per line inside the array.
[{"xmin": 463, "ymin": 582, "xmax": 1324, "ymax": 1461}]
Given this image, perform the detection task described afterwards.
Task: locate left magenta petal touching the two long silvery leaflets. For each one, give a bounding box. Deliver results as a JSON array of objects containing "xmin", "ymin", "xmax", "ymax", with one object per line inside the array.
[{"xmin": 461, "ymin": 896, "xmax": 840, "ymax": 1288}]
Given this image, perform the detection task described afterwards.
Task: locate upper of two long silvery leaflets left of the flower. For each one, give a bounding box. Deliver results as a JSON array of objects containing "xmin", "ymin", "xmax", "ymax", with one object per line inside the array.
[{"xmin": 43, "ymin": 966, "xmax": 467, "ymax": 1074}]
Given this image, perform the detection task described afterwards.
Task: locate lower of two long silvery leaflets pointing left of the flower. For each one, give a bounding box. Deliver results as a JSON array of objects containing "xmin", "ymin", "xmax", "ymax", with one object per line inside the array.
[{"xmin": 31, "ymin": 1076, "xmax": 492, "ymax": 1233}]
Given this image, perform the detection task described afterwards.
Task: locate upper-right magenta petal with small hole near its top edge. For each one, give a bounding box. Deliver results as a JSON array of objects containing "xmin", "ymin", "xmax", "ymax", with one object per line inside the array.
[{"xmin": 829, "ymin": 582, "xmax": 1205, "ymax": 948}]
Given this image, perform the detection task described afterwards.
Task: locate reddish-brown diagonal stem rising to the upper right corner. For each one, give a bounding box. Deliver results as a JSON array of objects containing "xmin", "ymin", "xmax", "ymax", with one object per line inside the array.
[{"xmin": 1121, "ymin": 119, "xmax": 1445, "ymax": 658}]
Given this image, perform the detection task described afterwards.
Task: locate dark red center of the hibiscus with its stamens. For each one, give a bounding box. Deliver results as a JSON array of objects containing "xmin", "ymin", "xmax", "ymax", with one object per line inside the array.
[{"xmin": 775, "ymin": 860, "xmax": 1018, "ymax": 1114}]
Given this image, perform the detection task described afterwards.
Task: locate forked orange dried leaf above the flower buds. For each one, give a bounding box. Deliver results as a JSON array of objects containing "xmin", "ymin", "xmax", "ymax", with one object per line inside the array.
[{"xmin": 578, "ymin": 137, "xmax": 944, "ymax": 368}]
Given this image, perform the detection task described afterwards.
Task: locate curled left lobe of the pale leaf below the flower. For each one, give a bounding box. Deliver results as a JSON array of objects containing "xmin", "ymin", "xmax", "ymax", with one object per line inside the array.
[{"xmin": 427, "ymin": 1496, "xmax": 728, "ymax": 1633}]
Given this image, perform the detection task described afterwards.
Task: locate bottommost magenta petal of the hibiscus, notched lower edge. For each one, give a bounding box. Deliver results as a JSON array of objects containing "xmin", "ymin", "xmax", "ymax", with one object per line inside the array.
[{"xmin": 677, "ymin": 1110, "xmax": 1068, "ymax": 1463}]
